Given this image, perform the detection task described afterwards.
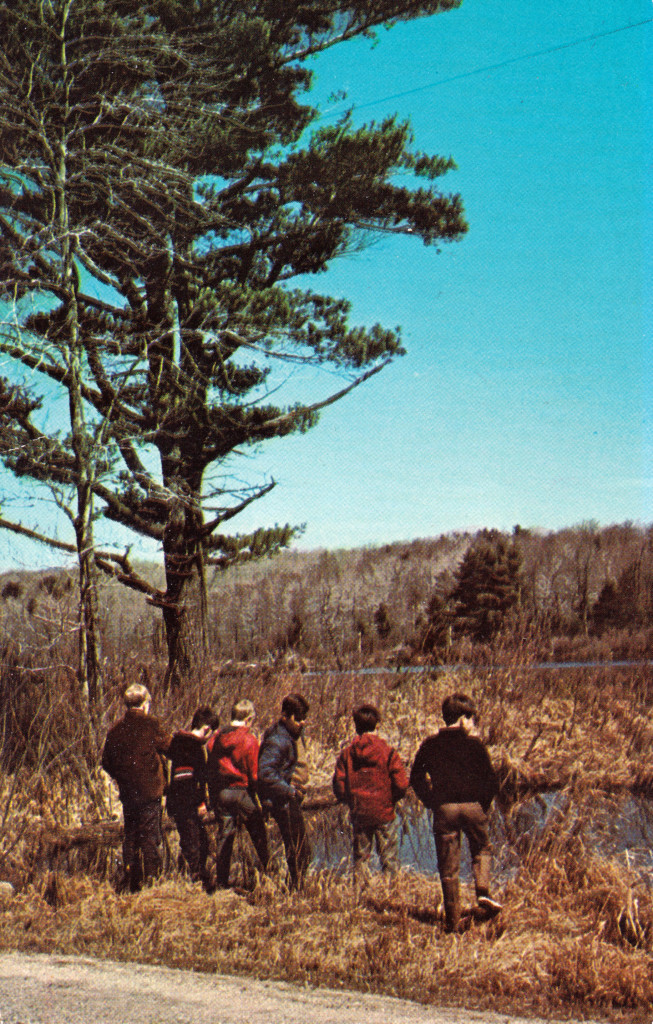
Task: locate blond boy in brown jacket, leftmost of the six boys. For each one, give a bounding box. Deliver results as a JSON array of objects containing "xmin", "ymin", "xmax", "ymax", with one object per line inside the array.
[{"xmin": 101, "ymin": 683, "xmax": 172, "ymax": 892}]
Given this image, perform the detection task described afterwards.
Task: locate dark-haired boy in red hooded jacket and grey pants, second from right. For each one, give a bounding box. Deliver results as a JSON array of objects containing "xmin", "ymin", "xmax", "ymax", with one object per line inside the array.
[{"xmin": 333, "ymin": 705, "xmax": 408, "ymax": 885}]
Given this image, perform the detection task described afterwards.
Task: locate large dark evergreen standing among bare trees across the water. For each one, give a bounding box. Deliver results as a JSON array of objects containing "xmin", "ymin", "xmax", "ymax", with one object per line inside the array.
[{"xmin": 449, "ymin": 530, "xmax": 522, "ymax": 642}]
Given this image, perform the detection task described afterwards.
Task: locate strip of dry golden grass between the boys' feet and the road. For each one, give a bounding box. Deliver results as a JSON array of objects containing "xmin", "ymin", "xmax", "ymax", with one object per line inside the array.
[{"xmin": 0, "ymin": 816, "xmax": 653, "ymax": 1021}]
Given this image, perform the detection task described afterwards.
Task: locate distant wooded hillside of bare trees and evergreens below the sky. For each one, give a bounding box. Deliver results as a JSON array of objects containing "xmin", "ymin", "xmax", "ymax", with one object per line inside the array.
[{"xmin": 0, "ymin": 522, "xmax": 653, "ymax": 668}]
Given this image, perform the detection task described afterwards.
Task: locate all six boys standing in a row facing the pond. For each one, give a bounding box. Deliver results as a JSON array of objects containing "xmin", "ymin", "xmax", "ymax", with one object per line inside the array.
[{"xmin": 102, "ymin": 684, "xmax": 500, "ymax": 932}]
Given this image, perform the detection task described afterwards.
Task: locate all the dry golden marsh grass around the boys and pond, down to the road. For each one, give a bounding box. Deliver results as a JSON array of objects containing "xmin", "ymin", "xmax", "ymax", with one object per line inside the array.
[{"xmin": 0, "ymin": 666, "xmax": 653, "ymax": 1024}]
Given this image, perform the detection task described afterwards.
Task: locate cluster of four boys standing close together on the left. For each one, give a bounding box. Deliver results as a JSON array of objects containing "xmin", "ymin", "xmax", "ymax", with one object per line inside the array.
[{"xmin": 101, "ymin": 683, "xmax": 310, "ymax": 892}]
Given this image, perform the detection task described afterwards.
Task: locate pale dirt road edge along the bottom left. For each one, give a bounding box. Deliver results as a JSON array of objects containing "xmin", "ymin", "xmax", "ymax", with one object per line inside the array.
[{"xmin": 0, "ymin": 953, "xmax": 610, "ymax": 1024}]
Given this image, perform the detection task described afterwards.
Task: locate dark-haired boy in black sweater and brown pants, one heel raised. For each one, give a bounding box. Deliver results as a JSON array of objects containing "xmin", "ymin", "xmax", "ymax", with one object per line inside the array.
[{"xmin": 410, "ymin": 693, "xmax": 502, "ymax": 932}]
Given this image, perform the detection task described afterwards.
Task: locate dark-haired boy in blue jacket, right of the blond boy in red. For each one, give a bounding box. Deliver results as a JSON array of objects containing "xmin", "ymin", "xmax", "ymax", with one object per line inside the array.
[{"xmin": 258, "ymin": 693, "xmax": 310, "ymax": 889}]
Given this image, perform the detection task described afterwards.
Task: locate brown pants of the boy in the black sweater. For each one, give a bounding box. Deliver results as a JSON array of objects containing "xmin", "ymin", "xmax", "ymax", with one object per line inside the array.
[{"xmin": 433, "ymin": 803, "xmax": 491, "ymax": 931}]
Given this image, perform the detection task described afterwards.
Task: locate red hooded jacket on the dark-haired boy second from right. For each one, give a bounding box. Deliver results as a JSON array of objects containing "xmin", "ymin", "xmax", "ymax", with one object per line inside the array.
[{"xmin": 333, "ymin": 732, "xmax": 408, "ymax": 825}]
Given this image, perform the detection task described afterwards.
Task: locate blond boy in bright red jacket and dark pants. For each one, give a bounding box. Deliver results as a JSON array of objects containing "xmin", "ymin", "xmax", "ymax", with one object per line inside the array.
[{"xmin": 208, "ymin": 699, "xmax": 268, "ymax": 889}]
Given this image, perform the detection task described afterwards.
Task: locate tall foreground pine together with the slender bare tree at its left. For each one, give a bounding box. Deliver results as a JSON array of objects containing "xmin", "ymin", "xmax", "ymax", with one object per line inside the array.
[{"xmin": 0, "ymin": 0, "xmax": 467, "ymax": 698}]
